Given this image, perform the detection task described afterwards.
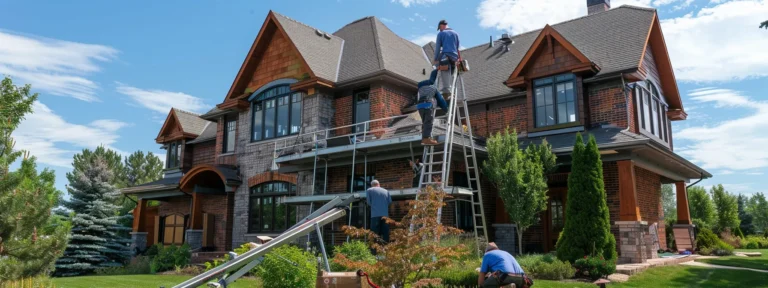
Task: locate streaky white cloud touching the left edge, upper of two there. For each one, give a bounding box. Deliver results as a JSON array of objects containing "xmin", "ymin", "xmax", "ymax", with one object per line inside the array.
[{"xmin": 0, "ymin": 30, "xmax": 119, "ymax": 102}]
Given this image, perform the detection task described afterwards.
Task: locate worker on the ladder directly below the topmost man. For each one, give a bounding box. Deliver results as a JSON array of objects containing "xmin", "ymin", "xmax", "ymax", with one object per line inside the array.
[{"xmin": 416, "ymin": 70, "xmax": 448, "ymax": 146}]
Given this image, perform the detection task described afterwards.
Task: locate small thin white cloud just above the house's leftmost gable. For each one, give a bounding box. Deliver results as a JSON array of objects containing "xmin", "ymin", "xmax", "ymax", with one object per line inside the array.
[{"xmin": 117, "ymin": 82, "xmax": 210, "ymax": 114}]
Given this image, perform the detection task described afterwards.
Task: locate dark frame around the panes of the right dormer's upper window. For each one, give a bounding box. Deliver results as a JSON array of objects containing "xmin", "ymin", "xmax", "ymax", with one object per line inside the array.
[{"xmin": 531, "ymin": 73, "xmax": 580, "ymax": 129}]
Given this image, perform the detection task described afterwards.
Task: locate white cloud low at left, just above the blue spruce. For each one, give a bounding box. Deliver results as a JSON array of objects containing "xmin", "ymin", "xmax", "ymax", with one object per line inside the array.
[{"xmin": 13, "ymin": 102, "xmax": 129, "ymax": 168}]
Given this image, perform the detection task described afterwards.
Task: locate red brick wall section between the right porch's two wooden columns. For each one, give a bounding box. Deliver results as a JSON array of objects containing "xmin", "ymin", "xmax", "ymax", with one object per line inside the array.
[{"xmin": 635, "ymin": 166, "xmax": 667, "ymax": 248}]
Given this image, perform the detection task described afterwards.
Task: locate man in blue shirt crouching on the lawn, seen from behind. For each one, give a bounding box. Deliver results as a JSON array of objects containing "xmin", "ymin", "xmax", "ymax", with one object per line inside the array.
[{"xmin": 477, "ymin": 242, "xmax": 533, "ymax": 288}]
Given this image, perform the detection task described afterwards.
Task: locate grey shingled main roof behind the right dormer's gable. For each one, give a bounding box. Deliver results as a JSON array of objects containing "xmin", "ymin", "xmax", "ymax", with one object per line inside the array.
[{"xmin": 460, "ymin": 5, "xmax": 656, "ymax": 100}]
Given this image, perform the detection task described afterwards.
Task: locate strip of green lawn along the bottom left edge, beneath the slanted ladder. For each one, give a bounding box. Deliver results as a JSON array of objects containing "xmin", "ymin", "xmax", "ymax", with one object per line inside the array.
[{"xmin": 52, "ymin": 275, "xmax": 261, "ymax": 288}]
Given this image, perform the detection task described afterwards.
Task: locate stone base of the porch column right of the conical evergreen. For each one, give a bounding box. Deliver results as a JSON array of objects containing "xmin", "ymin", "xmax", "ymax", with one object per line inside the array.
[{"xmin": 614, "ymin": 221, "xmax": 653, "ymax": 263}]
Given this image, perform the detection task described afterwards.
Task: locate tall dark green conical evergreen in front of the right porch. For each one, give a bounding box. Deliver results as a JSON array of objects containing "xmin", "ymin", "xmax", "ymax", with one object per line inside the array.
[{"xmin": 557, "ymin": 133, "xmax": 617, "ymax": 263}]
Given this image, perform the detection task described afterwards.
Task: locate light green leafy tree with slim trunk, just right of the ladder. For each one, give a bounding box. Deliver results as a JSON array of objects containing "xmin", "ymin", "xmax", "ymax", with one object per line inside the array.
[{"xmin": 483, "ymin": 129, "xmax": 556, "ymax": 252}]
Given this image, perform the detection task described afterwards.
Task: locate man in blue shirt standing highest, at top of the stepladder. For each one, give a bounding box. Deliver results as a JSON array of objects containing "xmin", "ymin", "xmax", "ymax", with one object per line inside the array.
[{"xmin": 432, "ymin": 20, "xmax": 461, "ymax": 99}]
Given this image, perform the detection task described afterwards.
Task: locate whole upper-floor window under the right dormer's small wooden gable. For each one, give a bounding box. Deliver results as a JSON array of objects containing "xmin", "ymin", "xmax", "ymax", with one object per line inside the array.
[{"xmin": 533, "ymin": 74, "xmax": 576, "ymax": 128}]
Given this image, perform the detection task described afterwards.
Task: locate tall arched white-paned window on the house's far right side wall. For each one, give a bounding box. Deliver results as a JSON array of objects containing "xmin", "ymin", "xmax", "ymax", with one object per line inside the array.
[{"xmin": 635, "ymin": 81, "xmax": 669, "ymax": 143}]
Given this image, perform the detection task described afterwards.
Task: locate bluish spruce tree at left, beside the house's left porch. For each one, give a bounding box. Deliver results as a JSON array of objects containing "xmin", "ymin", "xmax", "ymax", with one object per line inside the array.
[{"xmin": 54, "ymin": 157, "xmax": 131, "ymax": 276}]
